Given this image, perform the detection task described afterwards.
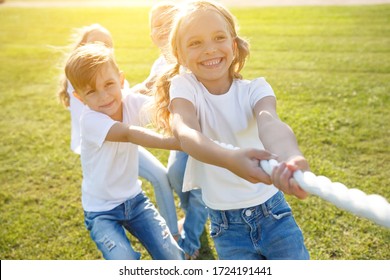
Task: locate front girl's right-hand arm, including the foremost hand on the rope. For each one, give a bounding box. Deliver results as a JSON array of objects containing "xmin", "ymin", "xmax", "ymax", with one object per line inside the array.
[{"xmin": 255, "ymin": 96, "xmax": 309, "ymax": 199}]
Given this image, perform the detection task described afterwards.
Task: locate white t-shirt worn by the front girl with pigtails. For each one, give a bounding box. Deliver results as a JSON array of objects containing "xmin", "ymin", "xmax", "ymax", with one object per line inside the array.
[{"xmin": 170, "ymin": 73, "xmax": 278, "ymax": 210}]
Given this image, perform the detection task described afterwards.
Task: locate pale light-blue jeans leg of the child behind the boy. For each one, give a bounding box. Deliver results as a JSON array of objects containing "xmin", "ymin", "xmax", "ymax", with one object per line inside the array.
[{"xmin": 138, "ymin": 146, "xmax": 179, "ymax": 235}]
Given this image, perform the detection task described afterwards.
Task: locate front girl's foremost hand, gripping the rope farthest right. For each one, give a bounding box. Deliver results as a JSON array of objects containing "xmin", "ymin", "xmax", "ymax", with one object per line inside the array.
[{"xmin": 271, "ymin": 156, "xmax": 309, "ymax": 199}]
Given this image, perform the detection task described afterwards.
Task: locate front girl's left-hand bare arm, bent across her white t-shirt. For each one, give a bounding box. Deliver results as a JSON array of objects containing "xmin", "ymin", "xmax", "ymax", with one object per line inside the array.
[{"xmin": 170, "ymin": 98, "xmax": 272, "ymax": 184}]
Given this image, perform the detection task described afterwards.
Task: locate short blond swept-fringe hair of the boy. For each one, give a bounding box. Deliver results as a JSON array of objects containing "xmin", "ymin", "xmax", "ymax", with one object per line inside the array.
[{"xmin": 65, "ymin": 42, "xmax": 120, "ymax": 95}]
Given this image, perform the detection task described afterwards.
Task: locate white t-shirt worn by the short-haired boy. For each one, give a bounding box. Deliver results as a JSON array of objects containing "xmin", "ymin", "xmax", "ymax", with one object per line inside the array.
[{"xmin": 80, "ymin": 93, "xmax": 149, "ymax": 212}]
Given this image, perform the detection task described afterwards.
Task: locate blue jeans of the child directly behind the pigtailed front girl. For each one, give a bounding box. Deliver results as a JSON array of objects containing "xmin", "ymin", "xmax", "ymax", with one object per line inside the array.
[{"xmin": 168, "ymin": 151, "xmax": 207, "ymax": 256}]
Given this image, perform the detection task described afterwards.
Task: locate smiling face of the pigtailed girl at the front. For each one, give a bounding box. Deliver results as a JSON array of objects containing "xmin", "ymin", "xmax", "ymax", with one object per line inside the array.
[{"xmin": 177, "ymin": 10, "xmax": 234, "ymax": 94}]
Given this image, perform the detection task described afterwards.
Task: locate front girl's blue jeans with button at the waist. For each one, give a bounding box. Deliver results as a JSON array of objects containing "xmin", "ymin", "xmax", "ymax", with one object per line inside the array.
[{"xmin": 209, "ymin": 192, "xmax": 309, "ymax": 260}]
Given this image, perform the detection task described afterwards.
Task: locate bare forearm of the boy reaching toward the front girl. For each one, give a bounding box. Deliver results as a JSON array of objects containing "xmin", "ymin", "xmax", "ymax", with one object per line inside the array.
[{"xmin": 105, "ymin": 122, "xmax": 181, "ymax": 150}]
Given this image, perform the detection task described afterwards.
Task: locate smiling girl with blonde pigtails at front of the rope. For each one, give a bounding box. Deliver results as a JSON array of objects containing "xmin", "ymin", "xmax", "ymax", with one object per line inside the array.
[{"xmin": 155, "ymin": 1, "xmax": 309, "ymax": 259}]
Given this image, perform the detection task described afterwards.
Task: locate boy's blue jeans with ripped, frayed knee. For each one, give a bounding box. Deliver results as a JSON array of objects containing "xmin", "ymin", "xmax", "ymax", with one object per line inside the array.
[{"xmin": 84, "ymin": 192, "xmax": 183, "ymax": 260}]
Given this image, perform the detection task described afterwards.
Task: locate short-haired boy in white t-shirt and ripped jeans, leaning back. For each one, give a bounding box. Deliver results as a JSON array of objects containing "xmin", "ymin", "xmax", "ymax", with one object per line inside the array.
[{"xmin": 65, "ymin": 44, "xmax": 183, "ymax": 259}]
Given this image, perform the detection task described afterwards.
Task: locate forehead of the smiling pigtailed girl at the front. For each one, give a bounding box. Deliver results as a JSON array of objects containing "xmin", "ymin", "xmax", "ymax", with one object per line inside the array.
[{"xmin": 179, "ymin": 9, "xmax": 229, "ymax": 40}]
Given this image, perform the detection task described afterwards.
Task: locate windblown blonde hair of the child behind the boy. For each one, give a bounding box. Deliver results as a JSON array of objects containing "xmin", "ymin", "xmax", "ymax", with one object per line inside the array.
[{"xmin": 57, "ymin": 23, "xmax": 113, "ymax": 107}]
